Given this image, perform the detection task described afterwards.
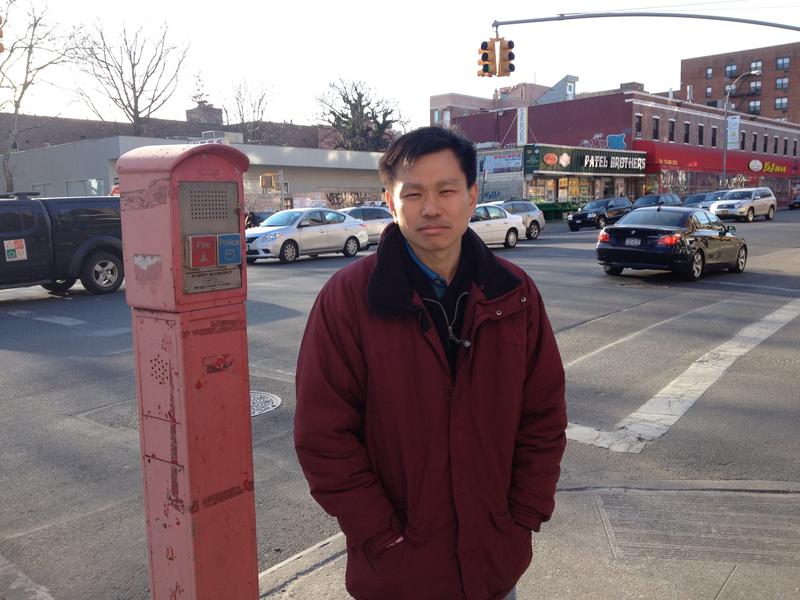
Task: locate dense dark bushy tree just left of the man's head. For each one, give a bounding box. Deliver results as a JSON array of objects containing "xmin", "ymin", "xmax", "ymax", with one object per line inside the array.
[{"xmin": 317, "ymin": 79, "xmax": 405, "ymax": 152}]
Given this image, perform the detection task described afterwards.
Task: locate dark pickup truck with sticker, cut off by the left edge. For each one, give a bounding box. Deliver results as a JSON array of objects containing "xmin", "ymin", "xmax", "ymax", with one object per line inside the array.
[{"xmin": 0, "ymin": 192, "xmax": 123, "ymax": 294}]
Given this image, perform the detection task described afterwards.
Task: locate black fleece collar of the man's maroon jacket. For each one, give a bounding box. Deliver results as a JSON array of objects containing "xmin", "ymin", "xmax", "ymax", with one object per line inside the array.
[{"xmin": 367, "ymin": 223, "xmax": 522, "ymax": 317}]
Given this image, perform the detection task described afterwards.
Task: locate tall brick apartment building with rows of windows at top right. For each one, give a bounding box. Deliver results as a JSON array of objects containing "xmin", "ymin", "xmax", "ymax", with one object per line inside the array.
[{"xmin": 679, "ymin": 42, "xmax": 800, "ymax": 123}]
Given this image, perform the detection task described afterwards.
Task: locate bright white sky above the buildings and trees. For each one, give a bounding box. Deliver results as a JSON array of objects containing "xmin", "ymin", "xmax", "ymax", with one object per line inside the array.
[{"xmin": 10, "ymin": 0, "xmax": 800, "ymax": 127}]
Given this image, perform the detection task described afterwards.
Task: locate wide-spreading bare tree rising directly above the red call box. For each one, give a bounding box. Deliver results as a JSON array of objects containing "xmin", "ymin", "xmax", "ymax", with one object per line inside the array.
[{"xmin": 80, "ymin": 24, "xmax": 189, "ymax": 135}]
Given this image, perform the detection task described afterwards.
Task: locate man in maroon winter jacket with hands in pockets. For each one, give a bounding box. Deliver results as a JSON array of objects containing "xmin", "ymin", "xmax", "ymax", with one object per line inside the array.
[{"xmin": 295, "ymin": 127, "xmax": 567, "ymax": 600}]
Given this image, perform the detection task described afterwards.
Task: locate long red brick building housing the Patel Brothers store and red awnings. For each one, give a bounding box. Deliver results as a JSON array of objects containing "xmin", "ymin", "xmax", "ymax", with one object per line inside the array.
[{"xmin": 452, "ymin": 84, "xmax": 800, "ymax": 204}]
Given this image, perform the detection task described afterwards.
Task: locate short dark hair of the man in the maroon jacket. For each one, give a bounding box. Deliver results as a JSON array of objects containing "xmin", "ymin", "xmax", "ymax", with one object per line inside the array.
[{"xmin": 378, "ymin": 127, "xmax": 478, "ymax": 192}]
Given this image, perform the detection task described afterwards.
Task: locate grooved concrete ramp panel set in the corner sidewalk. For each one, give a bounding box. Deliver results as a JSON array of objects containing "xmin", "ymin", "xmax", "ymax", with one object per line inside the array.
[{"xmin": 595, "ymin": 490, "xmax": 800, "ymax": 567}]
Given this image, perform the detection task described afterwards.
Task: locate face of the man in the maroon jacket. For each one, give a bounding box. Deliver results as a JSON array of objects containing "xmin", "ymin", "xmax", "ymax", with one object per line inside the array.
[{"xmin": 386, "ymin": 150, "xmax": 478, "ymax": 260}]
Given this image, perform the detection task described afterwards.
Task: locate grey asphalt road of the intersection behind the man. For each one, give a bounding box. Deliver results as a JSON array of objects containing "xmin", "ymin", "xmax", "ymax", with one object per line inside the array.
[{"xmin": 0, "ymin": 211, "xmax": 800, "ymax": 600}]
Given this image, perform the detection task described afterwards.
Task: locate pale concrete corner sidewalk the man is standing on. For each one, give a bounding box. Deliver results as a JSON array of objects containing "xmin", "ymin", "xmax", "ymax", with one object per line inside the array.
[{"xmin": 259, "ymin": 481, "xmax": 800, "ymax": 600}]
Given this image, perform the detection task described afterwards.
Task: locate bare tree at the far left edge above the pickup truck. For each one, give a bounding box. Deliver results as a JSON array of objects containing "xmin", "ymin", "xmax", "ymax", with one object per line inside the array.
[{"xmin": 0, "ymin": 0, "xmax": 81, "ymax": 192}]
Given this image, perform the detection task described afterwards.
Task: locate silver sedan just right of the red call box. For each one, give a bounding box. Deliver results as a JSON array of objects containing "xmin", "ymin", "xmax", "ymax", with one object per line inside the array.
[{"xmin": 245, "ymin": 208, "xmax": 369, "ymax": 264}]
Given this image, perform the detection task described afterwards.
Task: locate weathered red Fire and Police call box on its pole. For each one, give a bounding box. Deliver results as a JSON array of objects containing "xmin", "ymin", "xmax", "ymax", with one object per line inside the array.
[{"xmin": 117, "ymin": 144, "xmax": 258, "ymax": 600}]
